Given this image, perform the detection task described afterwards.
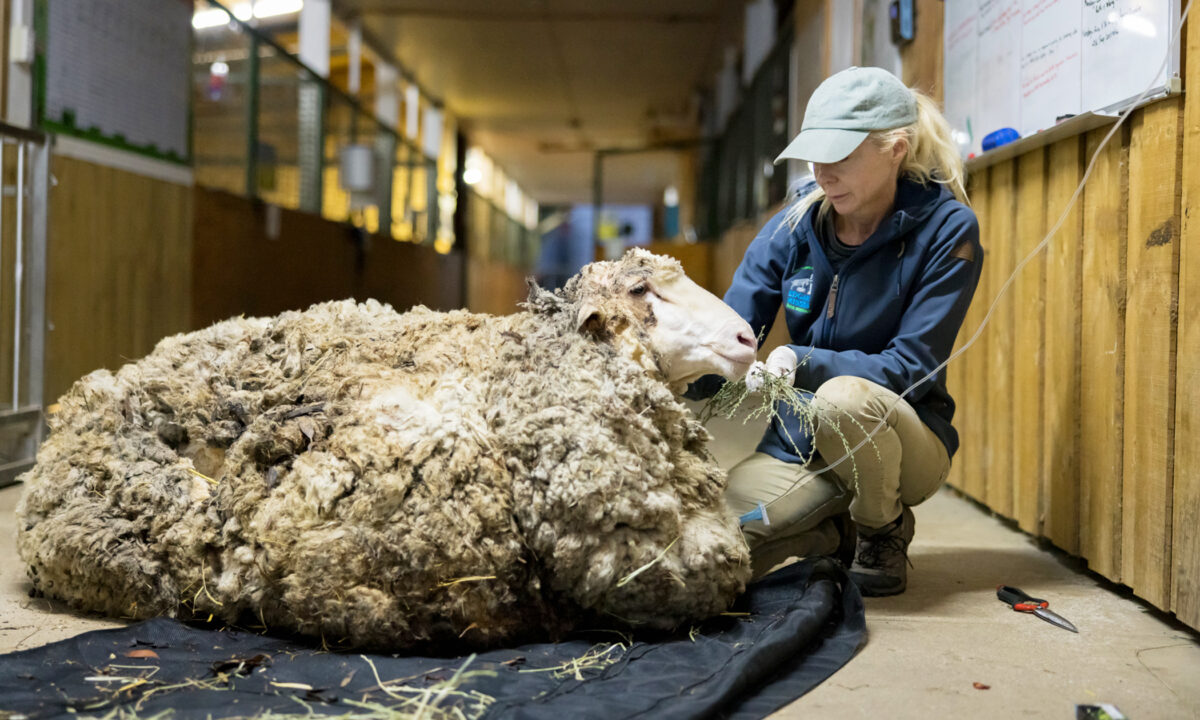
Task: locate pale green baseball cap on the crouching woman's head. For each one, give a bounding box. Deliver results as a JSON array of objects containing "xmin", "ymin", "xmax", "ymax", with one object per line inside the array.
[{"xmin": 775, "ymin": 67, "xmax": 917, "ymax": 163}]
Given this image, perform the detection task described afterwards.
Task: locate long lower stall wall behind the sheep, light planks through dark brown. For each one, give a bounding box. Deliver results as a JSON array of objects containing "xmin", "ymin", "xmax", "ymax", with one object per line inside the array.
[{"xmin": 35, "ymin": 172, "xmax": 462, "ymax": 402}]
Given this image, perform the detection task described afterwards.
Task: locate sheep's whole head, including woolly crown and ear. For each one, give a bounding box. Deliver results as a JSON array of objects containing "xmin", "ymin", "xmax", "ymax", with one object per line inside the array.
[{"xmin": 568, "ymin": 248, "xmax": 757, "ymax": 390}]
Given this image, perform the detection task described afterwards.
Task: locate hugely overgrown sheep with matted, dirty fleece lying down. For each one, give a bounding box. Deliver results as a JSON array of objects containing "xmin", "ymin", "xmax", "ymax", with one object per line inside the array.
[{"xmin": 17, "ymin": 251, "xmax": 755, "ymax": 649}]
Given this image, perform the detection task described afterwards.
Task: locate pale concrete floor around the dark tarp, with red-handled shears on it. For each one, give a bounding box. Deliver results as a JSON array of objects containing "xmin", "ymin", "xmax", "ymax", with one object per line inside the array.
[{"xmin": 0, "ymin": 403, "xmax": 1200, "ymax": 720}]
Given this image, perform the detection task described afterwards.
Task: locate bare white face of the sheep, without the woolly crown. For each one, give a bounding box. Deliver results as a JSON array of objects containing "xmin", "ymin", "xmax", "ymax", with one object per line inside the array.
[{"xmin": 630, "ymin": 272, "xmax": 758, "ymax": 384}]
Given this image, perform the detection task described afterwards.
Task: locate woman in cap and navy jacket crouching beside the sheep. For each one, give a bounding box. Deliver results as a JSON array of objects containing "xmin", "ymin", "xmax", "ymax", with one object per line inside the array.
[{"xmin": 725, "ymin": 67, "xmax": 983, "ymax": 595}]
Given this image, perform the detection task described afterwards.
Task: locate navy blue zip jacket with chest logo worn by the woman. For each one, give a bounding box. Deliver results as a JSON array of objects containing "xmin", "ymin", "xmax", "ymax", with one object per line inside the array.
[{"xmin": 705, "ymin": 179, "xmax": 983, "ymax": 462}]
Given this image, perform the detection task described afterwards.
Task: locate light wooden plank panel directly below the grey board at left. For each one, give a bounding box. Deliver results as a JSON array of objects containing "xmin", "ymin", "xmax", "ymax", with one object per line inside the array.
[{"xmin": 44, "ymin": 156, "xmax": 192, "ymax": 402}]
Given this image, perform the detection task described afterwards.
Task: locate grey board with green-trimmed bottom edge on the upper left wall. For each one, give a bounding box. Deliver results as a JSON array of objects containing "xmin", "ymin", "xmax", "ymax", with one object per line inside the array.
[{"xmin": 42, "ymin": 0, "xmax": 192, "ymax": 161}]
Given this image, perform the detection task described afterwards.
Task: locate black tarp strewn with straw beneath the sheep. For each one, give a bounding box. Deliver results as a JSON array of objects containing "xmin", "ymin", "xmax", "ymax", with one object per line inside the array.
[{"xmin": 0, "ymin": 560, "xmax": 865, "ymax": 720}]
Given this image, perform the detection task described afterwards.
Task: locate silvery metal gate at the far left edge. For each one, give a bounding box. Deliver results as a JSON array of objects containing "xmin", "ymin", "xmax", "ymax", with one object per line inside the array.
[{"xmin": 0, "ymin": 122, "xmax": 50, "ymax": 487}]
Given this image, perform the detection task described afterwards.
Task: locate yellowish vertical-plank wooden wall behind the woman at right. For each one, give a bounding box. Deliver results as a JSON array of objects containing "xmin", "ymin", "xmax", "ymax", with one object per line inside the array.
[{"xmin": 905, "ymin": 11, "xmax": 1200, "ymax": 628}]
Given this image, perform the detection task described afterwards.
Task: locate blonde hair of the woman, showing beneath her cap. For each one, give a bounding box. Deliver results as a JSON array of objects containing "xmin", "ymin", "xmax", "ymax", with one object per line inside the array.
[{"xmin": 786, "ymin": 90, "xmax": 971, "ymax": 229}]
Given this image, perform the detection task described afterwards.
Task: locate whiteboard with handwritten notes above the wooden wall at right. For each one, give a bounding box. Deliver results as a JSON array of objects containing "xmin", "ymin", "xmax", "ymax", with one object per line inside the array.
[{"xmin": 943, "ymin": 0, "xmax": 1180, "ymax": 156}]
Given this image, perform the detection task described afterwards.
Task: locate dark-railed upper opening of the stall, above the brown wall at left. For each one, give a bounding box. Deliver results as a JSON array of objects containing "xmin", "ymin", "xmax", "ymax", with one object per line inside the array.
[{"xmin": 192, "ymin": 0, "xmax": 438, "ymax": 242}]
